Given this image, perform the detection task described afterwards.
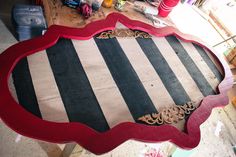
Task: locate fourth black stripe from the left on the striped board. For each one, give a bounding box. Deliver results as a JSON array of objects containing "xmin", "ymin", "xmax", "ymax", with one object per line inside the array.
[{"xmin": 136, "ymin": 38, "xmax": 190, "ymax": 105}]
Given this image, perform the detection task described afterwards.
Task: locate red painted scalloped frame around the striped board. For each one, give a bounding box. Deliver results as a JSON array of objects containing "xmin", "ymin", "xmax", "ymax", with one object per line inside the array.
[{"xmin": 0, "ymin": 13, "xmax": 233, "ymax": 154}]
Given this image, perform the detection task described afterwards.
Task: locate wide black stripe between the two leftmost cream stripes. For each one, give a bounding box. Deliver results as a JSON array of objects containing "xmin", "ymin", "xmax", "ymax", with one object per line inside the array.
[{"xmin": 47, "ymin": 39, "xmax": 109, "ymax": 132}]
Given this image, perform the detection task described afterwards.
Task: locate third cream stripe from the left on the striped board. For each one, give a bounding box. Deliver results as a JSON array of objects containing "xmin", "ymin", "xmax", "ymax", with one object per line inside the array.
[{"xmin": 117, "ymin": 38, "xmax": 175, "ymax": 110}]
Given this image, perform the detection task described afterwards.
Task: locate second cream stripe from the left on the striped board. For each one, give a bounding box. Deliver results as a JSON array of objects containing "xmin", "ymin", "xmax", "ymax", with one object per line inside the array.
[{"xmin": 72, "ymin": 39, "xmax": 134, "ymax": 127}]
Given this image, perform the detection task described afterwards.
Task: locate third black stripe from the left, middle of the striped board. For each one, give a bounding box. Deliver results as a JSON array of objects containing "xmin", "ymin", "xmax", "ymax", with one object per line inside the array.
[{"xmin": 94, "ymin": 38, "xmax": 157, "ymax": 121}]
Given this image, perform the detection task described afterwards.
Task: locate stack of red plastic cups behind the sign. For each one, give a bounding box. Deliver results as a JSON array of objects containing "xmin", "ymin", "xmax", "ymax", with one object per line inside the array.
[{"xmin": 158, "ymin": 0, "xmax": 180, "ymax": 17}]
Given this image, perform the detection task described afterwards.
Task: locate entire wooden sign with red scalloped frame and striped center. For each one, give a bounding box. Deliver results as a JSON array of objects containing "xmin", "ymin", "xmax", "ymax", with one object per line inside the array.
[{"xmin": 0, "ymin": 13, "xmax": 232, "ymax": 154}]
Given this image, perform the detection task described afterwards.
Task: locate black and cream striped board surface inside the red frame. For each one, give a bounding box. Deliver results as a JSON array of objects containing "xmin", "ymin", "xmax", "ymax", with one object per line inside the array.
[{"xmin": 10, "ymin": 36, "xmax": 223, "ymax": 132}]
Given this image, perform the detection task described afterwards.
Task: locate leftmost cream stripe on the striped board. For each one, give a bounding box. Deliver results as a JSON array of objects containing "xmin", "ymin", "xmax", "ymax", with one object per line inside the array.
[{"xmin": 27, "ymin": 51, "xmax": 69, "ymax": 122}]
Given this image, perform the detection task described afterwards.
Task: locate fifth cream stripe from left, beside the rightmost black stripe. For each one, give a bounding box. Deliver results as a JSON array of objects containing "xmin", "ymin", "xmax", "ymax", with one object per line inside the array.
[{"xmin": 180, "ymin": 40, "xmax": 219, "ymax": 90}]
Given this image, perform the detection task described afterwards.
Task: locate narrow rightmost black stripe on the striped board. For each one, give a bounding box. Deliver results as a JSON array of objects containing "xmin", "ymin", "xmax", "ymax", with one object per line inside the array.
[{"xmin": 193, "ymin": 43, "xmax": 224, "ymax": 82}]
